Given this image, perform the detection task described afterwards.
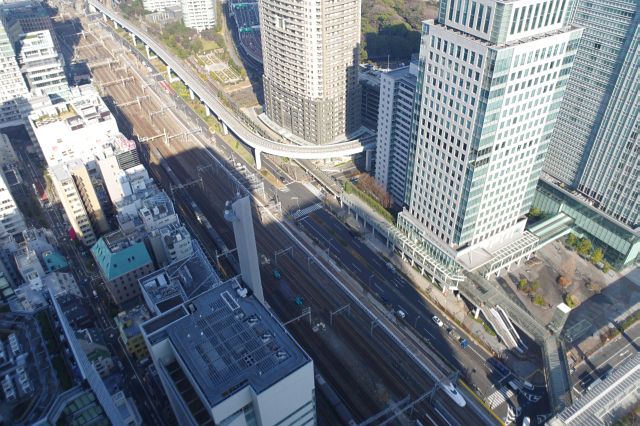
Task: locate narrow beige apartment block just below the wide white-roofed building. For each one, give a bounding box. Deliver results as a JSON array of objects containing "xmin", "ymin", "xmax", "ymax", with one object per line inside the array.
[{"xmin": 49, "ymin": 159, "xmax": 109, "ymax": 246}]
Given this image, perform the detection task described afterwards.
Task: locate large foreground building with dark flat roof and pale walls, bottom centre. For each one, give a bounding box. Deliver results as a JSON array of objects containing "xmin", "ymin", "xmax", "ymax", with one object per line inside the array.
[{"xmin": 142, "ymin": 281, "xmax": 316, "ymax": 426}]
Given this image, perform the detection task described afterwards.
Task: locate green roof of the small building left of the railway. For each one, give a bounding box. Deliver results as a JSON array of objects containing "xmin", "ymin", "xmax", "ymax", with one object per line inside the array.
[{"xmin": 91, "ymin": 237, "xmax": 151, "ymax": 281}]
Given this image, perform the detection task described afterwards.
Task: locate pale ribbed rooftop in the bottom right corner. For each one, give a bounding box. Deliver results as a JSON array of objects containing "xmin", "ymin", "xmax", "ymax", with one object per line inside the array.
[{"xmin": 548, "ymin": 353, "xmax": 640, "ymax": 426}]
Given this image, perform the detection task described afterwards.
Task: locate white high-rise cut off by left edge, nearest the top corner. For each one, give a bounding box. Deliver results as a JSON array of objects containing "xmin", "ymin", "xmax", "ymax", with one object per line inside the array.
[{"xmin": 0, "ymin": 15, "xmax": 29, "ymax": 127}]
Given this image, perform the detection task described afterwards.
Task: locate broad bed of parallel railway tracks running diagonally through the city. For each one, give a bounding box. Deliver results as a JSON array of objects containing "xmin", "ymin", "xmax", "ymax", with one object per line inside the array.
[{"xmin": 55, "ymin": 15, "xmax": 496, "ymax": 424}]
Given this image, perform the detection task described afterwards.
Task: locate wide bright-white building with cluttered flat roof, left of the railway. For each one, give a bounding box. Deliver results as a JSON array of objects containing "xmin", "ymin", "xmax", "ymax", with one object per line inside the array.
[{"xmin": 29, "ymin": 85, "xmax": 120, "ymax": 168}]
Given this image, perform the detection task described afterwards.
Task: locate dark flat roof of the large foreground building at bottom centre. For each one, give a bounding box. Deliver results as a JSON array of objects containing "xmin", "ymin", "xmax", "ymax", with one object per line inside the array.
[{"xmin": 143, "ymin": 281, "xmax": 311, "ymax": 407}]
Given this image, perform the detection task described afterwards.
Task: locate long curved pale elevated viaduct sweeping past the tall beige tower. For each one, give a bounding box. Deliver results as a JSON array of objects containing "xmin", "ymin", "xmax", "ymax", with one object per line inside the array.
[{"xmin": 88, "ymin": 0, "xmax": 373, "ymax": 168}]
